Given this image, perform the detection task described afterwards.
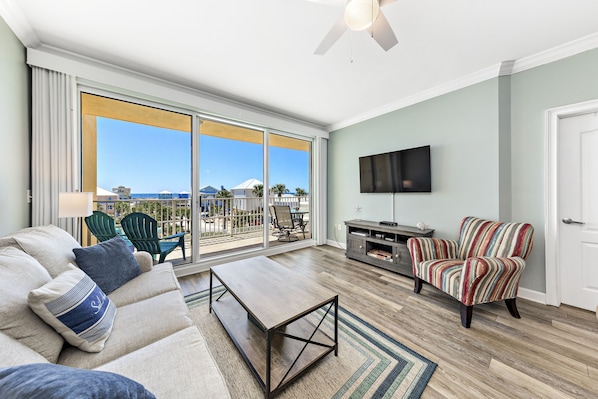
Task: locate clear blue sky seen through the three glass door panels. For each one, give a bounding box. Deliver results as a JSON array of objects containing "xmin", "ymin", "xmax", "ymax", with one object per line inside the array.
[{"xmin": 97, "ymin": 118, "xmax": 309, "ymax": 194}]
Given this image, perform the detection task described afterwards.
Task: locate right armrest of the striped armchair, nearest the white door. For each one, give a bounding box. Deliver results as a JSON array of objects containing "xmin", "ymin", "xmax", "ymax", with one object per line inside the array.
[{"xmin": 458, "ymin": 257, "xmax": 525, "ymax": 306}]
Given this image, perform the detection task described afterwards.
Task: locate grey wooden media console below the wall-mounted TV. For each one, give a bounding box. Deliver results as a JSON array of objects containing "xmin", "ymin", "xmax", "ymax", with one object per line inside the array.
[{"xmin": 345, "ymin": 219, "xmax": 434, "ymax": 277}]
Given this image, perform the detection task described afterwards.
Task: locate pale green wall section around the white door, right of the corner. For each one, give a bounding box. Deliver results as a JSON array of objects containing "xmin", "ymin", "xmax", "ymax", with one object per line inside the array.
[{"xmin": 511, "ymin": 50, "xmax": 598, "ymax": 292}]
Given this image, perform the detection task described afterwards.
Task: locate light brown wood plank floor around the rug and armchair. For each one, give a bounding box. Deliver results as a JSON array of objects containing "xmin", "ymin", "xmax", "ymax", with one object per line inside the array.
[{"xmin": 180, "ymin": 246, "xmax": 598, "ymax": 398}]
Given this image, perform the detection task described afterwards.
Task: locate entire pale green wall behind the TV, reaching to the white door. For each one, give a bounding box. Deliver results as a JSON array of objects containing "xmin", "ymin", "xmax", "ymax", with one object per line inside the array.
[{"xmin": 328, "ymin": 49, "xmax": 598, "ymax": 292}]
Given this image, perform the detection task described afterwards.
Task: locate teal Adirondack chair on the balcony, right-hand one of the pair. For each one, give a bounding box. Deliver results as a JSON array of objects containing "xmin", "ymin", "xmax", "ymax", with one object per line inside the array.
[{"xmin": 120, "ymin": 212, "xmax": 187, "ymax": 263}]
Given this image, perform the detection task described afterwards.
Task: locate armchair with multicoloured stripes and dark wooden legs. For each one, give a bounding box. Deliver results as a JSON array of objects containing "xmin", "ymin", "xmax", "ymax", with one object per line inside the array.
[{"xmin": 407, "ymin": 217, "xmax": 534, "ymax": 328}]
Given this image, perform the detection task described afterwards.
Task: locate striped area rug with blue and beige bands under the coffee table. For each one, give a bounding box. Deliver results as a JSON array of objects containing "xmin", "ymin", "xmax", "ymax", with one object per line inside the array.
[{"xmin": 185, "ymin": 289, "xmax": 436, "ymax": 399}]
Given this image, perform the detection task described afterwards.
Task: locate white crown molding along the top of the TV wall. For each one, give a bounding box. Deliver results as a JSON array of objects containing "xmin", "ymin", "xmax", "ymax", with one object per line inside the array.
[{"xmin": 327, "ymin": 33, "xmax": 598, "ymax": 132}]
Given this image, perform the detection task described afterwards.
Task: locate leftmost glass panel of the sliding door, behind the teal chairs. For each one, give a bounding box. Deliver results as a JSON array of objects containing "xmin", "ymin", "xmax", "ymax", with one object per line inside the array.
[{"xmin": 81, "ymin": 93, "xmax": 192, "ymax": 265}]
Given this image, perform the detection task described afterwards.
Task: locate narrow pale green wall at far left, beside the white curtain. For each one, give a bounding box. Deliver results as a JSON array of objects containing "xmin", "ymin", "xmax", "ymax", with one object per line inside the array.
[{"xmin": 0, "ymin": 18, "xmax": 31, "ymax": 236}]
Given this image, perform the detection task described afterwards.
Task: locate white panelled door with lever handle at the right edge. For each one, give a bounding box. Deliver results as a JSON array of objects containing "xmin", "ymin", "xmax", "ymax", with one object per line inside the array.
[{"xmin": 558, "ymin": 113, "xmax": 598, "ymax": 311}]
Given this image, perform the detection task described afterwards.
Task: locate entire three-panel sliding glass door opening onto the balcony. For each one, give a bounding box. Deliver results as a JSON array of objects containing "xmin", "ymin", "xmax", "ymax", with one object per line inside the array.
[{"xmin": 81, "ymin": 92, "xmax": 315, "ymax": 266}]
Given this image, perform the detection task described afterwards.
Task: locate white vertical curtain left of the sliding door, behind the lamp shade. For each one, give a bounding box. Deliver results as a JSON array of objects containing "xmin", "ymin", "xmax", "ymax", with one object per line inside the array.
[{"xmin": 31, "ymin": 66, "xmax": 81, "ymax": 240}]
